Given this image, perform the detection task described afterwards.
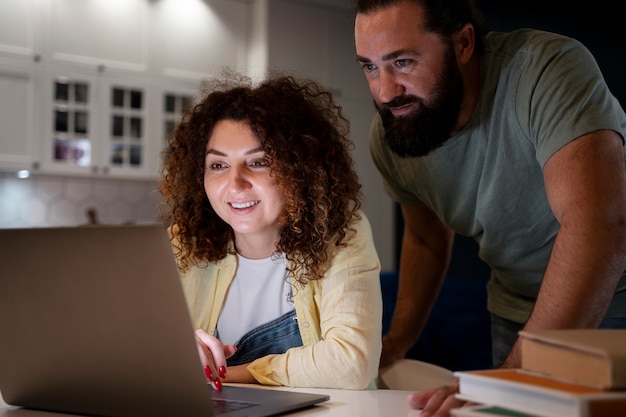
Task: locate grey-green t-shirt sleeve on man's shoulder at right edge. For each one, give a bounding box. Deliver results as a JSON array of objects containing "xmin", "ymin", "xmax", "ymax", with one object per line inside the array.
[{"xmin": 516, "ymin": 34, "xmax": 626, "ymax": 166}]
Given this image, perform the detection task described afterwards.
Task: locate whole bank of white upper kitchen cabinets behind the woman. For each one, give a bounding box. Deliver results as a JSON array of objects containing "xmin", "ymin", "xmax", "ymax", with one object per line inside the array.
[{"xmin": 0, "ymin": 0, "xmax": 248, "ymax": 179}]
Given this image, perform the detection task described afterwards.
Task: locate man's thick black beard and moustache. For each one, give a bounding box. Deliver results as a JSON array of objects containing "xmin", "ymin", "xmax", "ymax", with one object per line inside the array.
[{"xmin": 374, "ymin": 47, "xmax": 463, "ymax": 158}]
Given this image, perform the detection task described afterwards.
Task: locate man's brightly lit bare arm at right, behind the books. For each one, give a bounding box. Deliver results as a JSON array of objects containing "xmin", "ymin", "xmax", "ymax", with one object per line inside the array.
[{"xmin": 503, "ymin": 130, "xmax": 626, "ymax": 367}]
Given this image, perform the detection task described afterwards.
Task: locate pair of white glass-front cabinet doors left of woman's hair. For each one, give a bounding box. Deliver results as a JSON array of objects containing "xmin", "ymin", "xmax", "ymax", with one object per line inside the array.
[{"xmin": 40, "ymin": 71, "xmax": 157, "ymax": 178}]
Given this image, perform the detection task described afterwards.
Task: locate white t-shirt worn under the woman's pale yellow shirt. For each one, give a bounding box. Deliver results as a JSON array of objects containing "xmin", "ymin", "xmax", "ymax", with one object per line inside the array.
[{"xmin": 217, "ymin": 255, "xmax": 293, "ymax": 345}]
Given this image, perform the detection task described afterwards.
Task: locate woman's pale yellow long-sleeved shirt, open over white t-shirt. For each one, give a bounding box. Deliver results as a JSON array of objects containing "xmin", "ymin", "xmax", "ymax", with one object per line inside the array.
[{"xmin": 176, "ymin": 212, "xmax": 382, "ymax": 389}]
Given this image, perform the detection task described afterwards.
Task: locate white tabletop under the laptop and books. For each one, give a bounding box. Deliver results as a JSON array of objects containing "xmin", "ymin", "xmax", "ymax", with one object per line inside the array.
[{"xmin": 0, "ymin": 385, "xmax": 419, "ymax": 417}]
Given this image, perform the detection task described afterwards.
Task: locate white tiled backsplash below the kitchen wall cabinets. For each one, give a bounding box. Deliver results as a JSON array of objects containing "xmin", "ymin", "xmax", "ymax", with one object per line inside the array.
[{"xmin": 0, "ymin": 173, "xmax": 161, "ymax": 228}]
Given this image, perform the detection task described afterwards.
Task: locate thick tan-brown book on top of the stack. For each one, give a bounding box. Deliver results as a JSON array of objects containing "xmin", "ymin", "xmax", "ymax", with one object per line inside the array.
[{"xmin": 519, "ymin": 329, "xmax": 626, "ymax": 390}]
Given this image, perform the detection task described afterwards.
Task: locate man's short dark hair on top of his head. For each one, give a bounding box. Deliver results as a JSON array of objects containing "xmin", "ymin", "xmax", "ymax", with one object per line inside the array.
[{"xmin": 353, "ymin": 0, "xmax": 485, "ymax": 52}]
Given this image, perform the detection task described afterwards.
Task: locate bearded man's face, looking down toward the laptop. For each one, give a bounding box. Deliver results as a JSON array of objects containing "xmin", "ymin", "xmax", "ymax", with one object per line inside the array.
[{"xmin": 355, "ymin": 2, "xmax": 463, "ymax": 157}]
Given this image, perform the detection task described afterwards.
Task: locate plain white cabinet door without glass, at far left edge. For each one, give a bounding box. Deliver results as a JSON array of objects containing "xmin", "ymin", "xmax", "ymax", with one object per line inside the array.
[{"xmin": 0, "ymin": 60, "xmax": 37, "ymax": 171}]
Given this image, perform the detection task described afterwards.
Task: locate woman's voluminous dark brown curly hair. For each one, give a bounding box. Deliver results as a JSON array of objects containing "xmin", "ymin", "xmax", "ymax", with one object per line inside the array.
[{"xmin": 159, "ymin": 72, "xmax": 361, "ymax": 284}]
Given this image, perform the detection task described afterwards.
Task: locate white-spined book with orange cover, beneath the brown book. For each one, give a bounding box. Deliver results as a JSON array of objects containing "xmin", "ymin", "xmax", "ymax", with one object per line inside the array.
[{"xmin": 454, "ymin": 369, "xmax": 626, "ymax": 417}]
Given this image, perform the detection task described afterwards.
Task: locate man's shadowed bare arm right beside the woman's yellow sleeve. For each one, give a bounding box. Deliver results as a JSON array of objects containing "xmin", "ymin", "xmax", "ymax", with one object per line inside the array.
[{"xmin": 380, "ymin": 205, "xmax": 454, "ymax": 367}]
